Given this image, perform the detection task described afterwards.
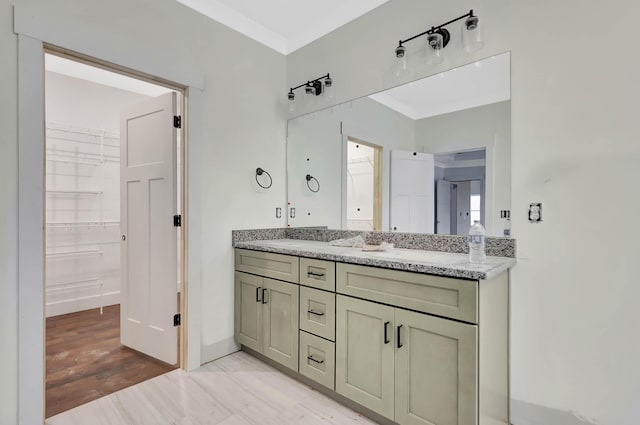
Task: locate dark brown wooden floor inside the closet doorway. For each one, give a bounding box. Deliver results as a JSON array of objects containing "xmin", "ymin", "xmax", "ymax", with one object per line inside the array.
[{"xmin": 46, "ymin": 305, "xmax": 175, "ymax": 423}]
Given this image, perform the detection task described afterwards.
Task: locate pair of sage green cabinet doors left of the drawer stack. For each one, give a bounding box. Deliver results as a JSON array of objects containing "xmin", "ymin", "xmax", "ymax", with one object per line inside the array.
[{"xmin": 235, "ymin": 272, "xmax": 299, "ymax": 371}]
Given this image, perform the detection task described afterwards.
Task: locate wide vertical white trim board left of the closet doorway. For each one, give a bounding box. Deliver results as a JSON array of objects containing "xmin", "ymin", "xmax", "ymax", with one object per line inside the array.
[{"xmin": 18, "ymin": 35, "xmax": 45, "ymax": 425}]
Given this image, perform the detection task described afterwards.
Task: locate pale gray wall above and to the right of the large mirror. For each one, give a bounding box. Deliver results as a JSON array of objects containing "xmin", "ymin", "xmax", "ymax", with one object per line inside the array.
[{"xmin": 287, "ymin": 0, "xmax": 640, "ymax": 425}]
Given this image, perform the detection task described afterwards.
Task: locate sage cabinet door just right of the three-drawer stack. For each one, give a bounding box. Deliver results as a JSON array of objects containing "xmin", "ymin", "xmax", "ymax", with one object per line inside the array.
[{"xmin": 336, "ymin": 295, "xmax": 394, "ymax": 419}]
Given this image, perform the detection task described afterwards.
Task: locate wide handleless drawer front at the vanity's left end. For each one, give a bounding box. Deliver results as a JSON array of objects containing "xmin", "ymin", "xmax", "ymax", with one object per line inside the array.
[{"xmin": 236, "ymin": 249, "xmax": 299, "ymax": 283}]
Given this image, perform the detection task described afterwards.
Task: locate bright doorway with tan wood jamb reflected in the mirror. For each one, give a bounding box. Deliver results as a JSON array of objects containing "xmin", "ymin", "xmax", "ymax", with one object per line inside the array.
[{"xmin": 345, "ymin": 137, "xmax": 382, "ymax": 231}]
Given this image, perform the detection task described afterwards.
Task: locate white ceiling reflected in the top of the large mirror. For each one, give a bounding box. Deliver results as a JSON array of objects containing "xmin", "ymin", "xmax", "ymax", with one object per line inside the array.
[{"xmin": 369, "ymin": 53, "xmax": 511, "ymax": 120}]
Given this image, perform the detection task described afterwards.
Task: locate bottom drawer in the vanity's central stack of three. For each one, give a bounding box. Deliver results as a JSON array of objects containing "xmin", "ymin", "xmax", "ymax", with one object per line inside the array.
[{"xmin": 299, "ymin": 331, "xmax": 336, "ymax": 390}]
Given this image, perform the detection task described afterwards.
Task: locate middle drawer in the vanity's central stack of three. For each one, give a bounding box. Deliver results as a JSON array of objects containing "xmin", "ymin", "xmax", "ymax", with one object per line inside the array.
[{"xmin": 300, "ymin": 286, "xmax": 336, "ymax": 341}]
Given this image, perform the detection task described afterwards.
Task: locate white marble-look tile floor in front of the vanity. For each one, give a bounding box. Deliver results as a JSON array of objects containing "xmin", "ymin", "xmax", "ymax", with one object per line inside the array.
[{"xmin": 45, "ymin": 352, "xmax": 375, "ymax": 425}]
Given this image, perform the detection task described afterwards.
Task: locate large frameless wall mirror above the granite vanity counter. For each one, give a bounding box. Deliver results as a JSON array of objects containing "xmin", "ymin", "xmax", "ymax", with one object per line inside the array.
[{"xmin": 287, "ymin": 53, "xmax": 511, "ymax": 236}]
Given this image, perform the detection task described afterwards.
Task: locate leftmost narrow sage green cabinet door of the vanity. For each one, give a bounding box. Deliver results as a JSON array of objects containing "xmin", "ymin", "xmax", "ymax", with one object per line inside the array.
[{"xmin": 235, "ymin": 272, "xmax": 264, "ymax": 353}]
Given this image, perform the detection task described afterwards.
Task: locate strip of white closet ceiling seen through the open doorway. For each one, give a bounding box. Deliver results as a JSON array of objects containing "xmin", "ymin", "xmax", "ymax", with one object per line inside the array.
[{"xmin": 44, "ymin": 54, "xmax": 173, "ymax": 97}]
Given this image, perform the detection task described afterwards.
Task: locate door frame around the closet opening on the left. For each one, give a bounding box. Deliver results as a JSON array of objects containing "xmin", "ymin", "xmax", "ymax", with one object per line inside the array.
[{"xmin": 17, "ymin": 36, "xmax": 202, "ymax": 424}]
